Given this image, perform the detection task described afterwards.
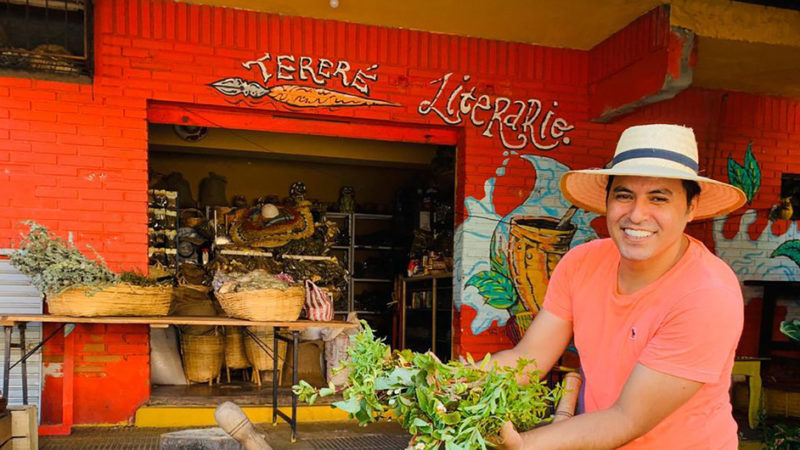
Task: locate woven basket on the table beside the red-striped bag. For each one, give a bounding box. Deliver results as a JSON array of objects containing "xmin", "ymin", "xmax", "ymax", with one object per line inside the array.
[{"xmin": 214, "ymin": 286, "xmax": 306, "ymax": 321}]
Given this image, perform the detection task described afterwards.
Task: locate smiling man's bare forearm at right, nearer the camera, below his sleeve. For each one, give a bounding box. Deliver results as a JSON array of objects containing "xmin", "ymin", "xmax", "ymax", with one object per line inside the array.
[{"xmin": 501, "ymin": 361, "xmax": 703, "ymax": 450}]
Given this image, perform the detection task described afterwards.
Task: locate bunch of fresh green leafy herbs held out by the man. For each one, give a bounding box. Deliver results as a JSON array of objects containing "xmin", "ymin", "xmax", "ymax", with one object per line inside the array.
[{"xmin": 293, "ymin": 321, "xmax": 562, "ymax": 450}]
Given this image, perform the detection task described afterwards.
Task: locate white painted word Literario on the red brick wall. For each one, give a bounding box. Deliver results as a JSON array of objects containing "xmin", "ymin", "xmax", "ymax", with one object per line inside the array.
[{"xmin": 417, "ymin": 73, "xmax": 575, "ymax": 151}]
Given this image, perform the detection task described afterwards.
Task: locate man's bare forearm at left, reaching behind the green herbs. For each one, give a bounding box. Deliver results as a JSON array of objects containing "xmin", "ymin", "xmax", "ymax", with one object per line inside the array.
[{"xmin": 492, "ymin": 309, "xmax": 572, "ymax": 382}]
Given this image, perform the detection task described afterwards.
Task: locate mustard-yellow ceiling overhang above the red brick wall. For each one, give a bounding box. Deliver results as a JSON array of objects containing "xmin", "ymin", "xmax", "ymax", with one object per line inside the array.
[{"xmin": 179, "ymin": 0, "xmax": 800, "ymax": 97}]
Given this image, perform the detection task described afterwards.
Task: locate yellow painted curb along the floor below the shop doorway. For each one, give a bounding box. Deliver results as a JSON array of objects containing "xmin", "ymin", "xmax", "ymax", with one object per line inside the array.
[{"xmin": 134, "ymin": 405, "xmax": 350, "ymax": 428}]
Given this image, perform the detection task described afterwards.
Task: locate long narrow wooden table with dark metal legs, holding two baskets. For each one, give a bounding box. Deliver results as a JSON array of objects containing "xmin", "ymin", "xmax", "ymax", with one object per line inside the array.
[{"xmin": 0, "ymin": 314, "xmax": 359, "ymax": 442}]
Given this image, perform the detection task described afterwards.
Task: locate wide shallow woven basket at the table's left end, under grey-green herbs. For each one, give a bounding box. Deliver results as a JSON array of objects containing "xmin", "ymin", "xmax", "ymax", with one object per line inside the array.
[{"xmin": 47, "ymin": 283, "xmax": 172, "ymax": 317}]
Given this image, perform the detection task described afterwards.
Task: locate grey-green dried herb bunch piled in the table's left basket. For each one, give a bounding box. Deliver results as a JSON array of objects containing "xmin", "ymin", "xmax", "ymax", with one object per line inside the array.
[{"xmin": 10, "ymin": 221, "xmax": 169, "ymax": 295}]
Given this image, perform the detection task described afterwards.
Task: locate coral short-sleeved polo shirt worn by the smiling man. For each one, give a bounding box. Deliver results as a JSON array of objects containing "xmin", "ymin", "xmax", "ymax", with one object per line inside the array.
[{"xmin": 544, "ymin": 236, "xmax": 744, "ymax": 449}]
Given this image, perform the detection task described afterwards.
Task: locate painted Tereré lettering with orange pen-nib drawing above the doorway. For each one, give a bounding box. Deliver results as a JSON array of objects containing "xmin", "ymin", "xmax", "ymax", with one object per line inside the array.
[{"xmin": 209, "ymin": 53, "xmax": 400, "ymax": 108}]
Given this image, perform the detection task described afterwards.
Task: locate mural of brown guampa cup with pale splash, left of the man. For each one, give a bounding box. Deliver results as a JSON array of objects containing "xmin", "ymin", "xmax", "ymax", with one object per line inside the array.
[{"xmin": 456, "ymin": 152, "xmax": 597, "ymax": 342}]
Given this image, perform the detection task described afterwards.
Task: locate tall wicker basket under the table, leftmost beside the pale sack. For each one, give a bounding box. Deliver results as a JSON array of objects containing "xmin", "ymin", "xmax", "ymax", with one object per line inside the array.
[{"xmin": 181, "ymin": 334, "xmax": 225, "ymax": 383}]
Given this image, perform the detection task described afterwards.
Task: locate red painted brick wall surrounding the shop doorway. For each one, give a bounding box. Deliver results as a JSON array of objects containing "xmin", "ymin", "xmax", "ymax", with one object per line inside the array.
[{"xmin": 0, "ymin": 0, "xmax": 800, "ymax": 423}]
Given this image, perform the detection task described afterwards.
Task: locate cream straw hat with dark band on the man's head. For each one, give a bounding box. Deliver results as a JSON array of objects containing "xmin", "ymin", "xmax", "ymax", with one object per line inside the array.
[{"xmin": 561, "ymin": 124, "xmax": 746, "ymax": 219}]
